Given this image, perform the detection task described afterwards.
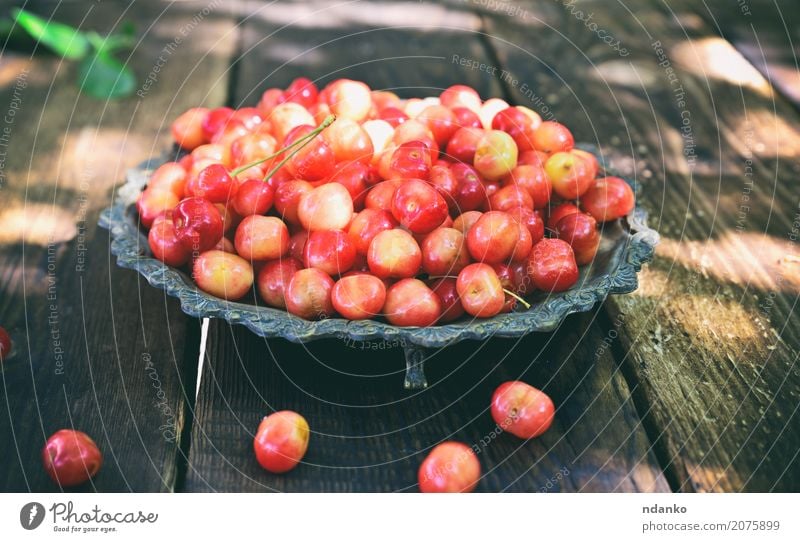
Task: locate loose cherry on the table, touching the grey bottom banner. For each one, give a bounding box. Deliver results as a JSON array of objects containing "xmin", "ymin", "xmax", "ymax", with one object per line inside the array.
[{"xmin": 417, "ymin": 442, "xmax": 481, "ymax": 493}]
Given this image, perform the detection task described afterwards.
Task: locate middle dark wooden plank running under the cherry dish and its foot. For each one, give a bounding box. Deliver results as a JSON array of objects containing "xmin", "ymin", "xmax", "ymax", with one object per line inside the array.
[{"xmin": 184, "ymin": 3, "xmax": 669, "ymax": 491}]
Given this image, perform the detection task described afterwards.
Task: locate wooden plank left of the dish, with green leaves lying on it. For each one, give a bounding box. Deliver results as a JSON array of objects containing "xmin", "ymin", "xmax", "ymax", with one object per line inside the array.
[{"xmin": 0, "ymin": 2, "xmax": 238, "ymax": 491}]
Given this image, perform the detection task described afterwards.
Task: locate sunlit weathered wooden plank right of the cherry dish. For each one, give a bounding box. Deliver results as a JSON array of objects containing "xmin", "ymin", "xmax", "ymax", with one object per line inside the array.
[{"xmin": 484, "ymin": 1, "xmax": 800, "ymax": 491}]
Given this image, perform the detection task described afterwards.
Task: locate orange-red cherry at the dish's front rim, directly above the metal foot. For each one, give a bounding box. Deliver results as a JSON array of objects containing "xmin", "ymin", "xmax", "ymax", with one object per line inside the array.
[{"xmin": 383, "ymin": 278, "xmax": 442, "ymax": 327}]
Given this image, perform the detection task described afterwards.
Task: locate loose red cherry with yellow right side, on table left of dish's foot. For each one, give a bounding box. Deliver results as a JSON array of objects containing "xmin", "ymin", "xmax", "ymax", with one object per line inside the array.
[{"xmin": 253, "ymin": 410, "xmax": 311, "ymax": 474}]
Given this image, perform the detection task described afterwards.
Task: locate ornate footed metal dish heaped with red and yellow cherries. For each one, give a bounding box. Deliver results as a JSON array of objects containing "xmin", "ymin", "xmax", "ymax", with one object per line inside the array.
[{"xmin": 100, "ymin": 78, "xmax": 658, "ymax": 389}]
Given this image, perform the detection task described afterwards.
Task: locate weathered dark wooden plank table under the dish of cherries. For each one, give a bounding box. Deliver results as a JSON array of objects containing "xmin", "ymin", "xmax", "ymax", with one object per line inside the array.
[{"xmin": 0, "ymin": 0, "xmax": 800, "ymax": 492}]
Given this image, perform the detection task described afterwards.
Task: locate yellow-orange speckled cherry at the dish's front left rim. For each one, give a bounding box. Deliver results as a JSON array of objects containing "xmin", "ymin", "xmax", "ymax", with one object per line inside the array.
[{"xmin": 192, "ymin": 250, "xmax": 253, "ymax": 301}]
